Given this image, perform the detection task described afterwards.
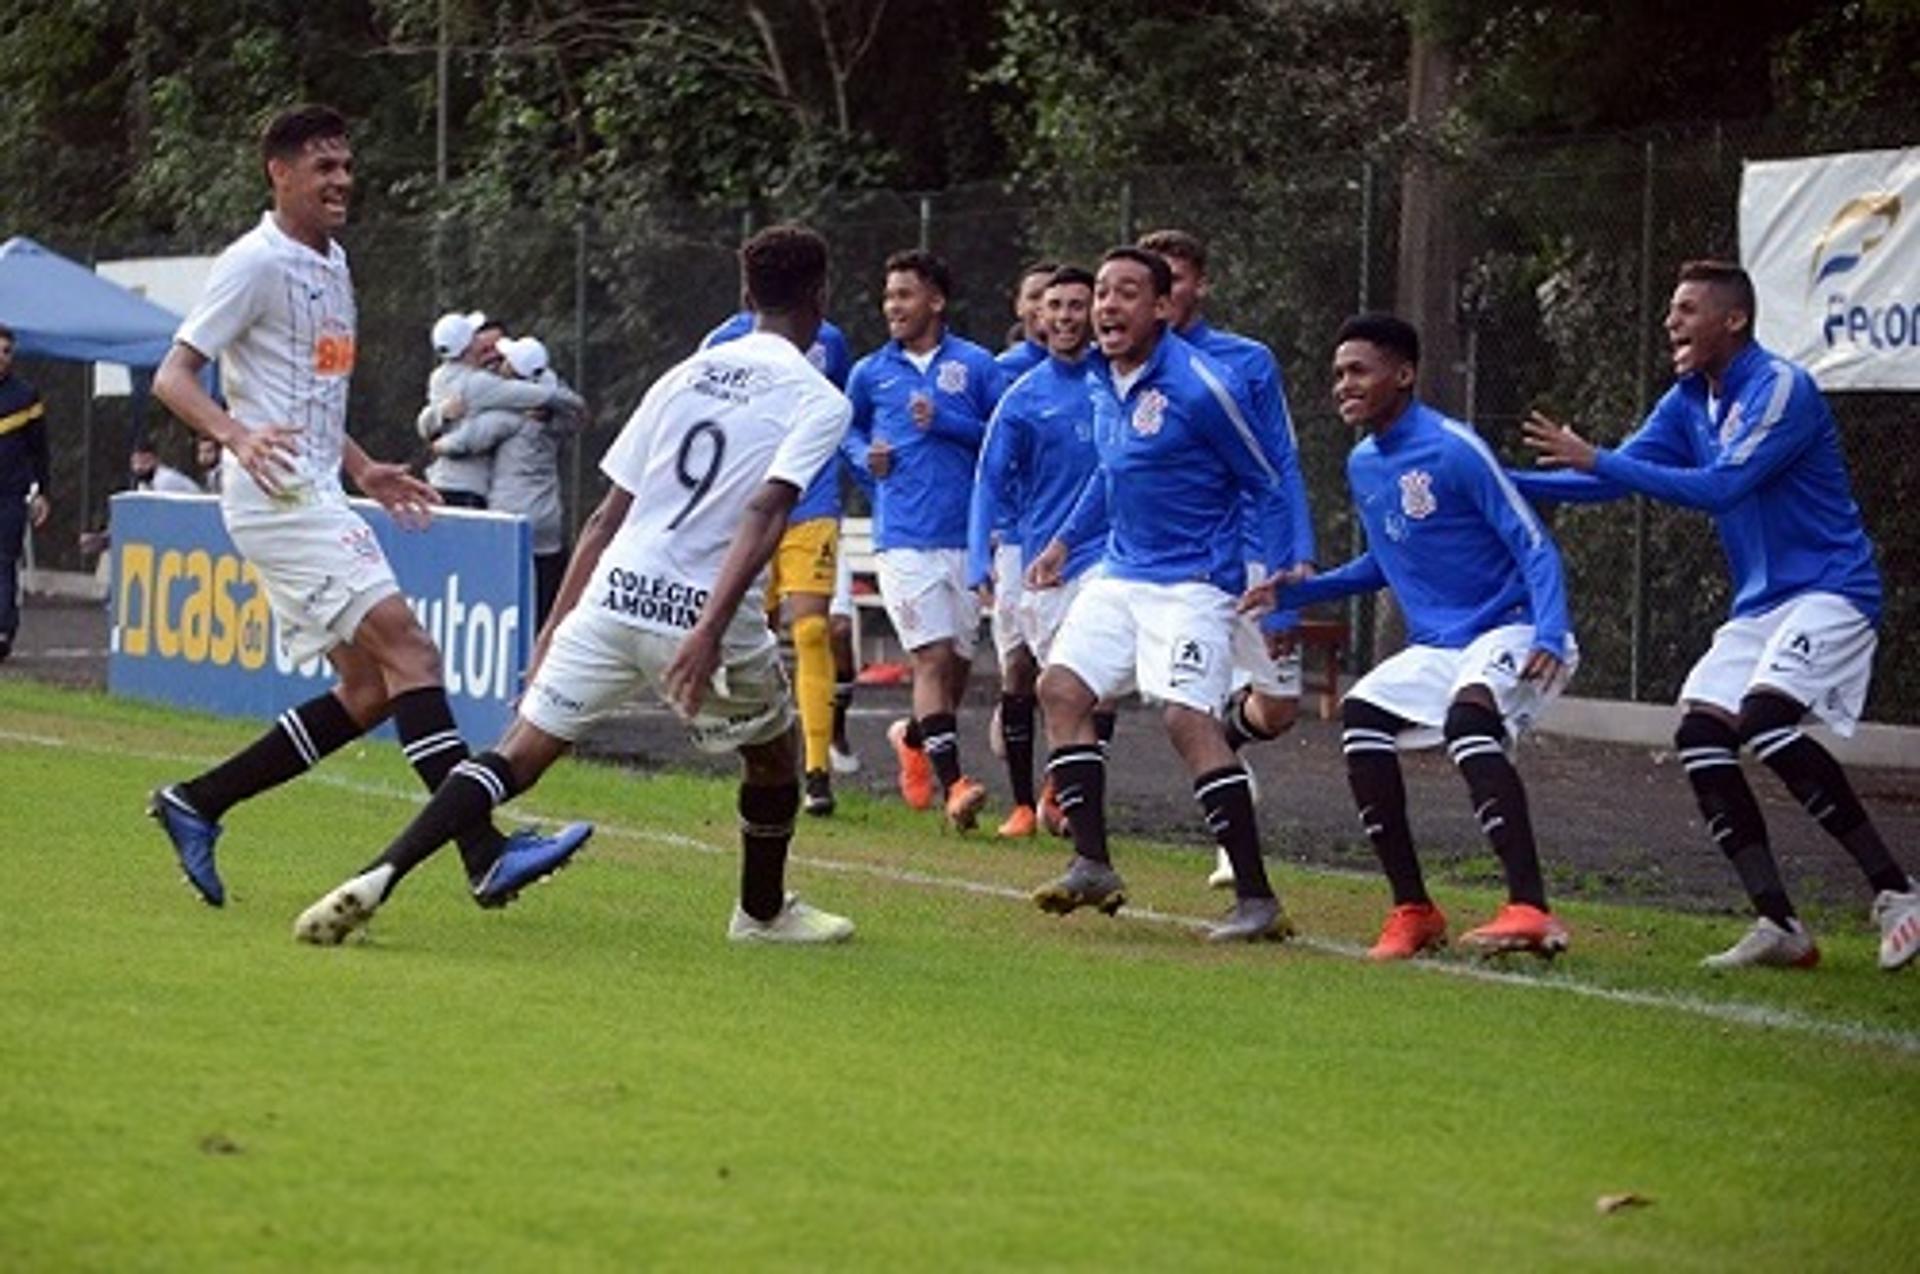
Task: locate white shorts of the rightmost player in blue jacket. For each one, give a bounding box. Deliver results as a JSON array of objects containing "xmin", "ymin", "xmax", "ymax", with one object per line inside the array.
[{"xmin": 1680, "ymin": 593, "xmax": 1880, "ymax": 737}]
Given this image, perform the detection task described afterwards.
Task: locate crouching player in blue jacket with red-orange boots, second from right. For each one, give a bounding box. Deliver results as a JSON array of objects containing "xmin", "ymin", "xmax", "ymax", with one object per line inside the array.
[{"xmin": 1244, "ymin": 315, "xmax": 1576, "ymax": 959}]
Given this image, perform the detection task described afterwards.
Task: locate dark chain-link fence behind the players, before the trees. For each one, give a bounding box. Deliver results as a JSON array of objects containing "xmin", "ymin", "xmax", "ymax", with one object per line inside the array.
[{"xmin": 25, "ymin": 129, "xmax": 1920, "ymax": 721}]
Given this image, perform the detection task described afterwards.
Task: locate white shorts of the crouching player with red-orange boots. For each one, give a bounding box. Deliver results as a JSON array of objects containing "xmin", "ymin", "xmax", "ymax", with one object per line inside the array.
[{"xmin": 1346, "ymin": 624, "xmax": 1580, "ymax": 748}]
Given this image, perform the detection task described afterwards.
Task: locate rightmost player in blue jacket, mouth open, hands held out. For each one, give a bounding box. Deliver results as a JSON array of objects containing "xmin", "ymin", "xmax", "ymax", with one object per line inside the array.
[{"xmin": 1515, "ymin": 261, "xmax": 1920, "ymax": 971}]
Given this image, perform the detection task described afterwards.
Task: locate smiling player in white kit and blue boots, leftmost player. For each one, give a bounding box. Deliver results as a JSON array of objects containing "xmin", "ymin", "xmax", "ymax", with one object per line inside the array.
[{"xmin": 150, "ymin": 106, "xmax": 586, "ymax": 908}]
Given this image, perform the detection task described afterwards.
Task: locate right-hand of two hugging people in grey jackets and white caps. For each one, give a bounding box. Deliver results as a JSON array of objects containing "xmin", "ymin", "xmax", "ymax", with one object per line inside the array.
[{"xmin": 434, "ymin": 336, "xmax": 586, "ymax": 631}]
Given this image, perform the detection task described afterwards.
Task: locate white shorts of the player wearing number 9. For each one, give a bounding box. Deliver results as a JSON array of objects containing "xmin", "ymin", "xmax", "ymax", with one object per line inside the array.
[{"xmin": 518, "ymin": 606, "xmax": 793, "ymax": 752}]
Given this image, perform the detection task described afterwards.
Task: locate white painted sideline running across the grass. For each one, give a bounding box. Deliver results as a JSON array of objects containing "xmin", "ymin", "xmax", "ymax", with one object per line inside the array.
[{"xmin": 0, "ymin": 729, "xmax": 1920, "ymax": 1053}]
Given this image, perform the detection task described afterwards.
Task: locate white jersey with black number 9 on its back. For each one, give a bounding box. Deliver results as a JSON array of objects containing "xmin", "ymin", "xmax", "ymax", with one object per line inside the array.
[{"xmin": 582, "ymin": 332, "xmax": 852, "ymax": 633}]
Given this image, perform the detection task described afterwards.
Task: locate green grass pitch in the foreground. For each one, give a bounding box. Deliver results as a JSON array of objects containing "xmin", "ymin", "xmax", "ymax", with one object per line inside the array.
[{"xmin": 0, "ymin": 683, "xmax": 1920, "ymax": 1270}]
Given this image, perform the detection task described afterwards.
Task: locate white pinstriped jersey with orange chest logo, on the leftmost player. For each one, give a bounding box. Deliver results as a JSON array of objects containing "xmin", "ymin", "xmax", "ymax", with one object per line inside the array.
[{"xmin": 175, "ymin": 213, "xmax": 355, "ymax": 510}]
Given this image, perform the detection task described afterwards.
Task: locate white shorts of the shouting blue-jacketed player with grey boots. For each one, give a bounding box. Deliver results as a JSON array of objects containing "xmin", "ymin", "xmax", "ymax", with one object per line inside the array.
[{"xmin": 1048, "ymin": 576, "xmax": 1235, "ymax": 718}]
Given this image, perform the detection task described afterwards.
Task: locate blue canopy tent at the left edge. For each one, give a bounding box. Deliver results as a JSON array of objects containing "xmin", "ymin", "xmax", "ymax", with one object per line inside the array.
[{"xmin": 0, "ymin": 236, "xmax": 180, "ymax": 537}]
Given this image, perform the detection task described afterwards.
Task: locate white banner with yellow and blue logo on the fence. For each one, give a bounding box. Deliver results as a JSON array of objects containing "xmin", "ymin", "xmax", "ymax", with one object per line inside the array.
[{"xmin": 1740, "ymin": 148, "xmax": 1920, "ymax": 389}]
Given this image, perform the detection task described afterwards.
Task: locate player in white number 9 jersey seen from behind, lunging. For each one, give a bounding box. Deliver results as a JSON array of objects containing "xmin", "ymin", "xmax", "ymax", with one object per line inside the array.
[{"xmin": 300, "ymin": 226, "xmax": 852, "ymax": 942}]
